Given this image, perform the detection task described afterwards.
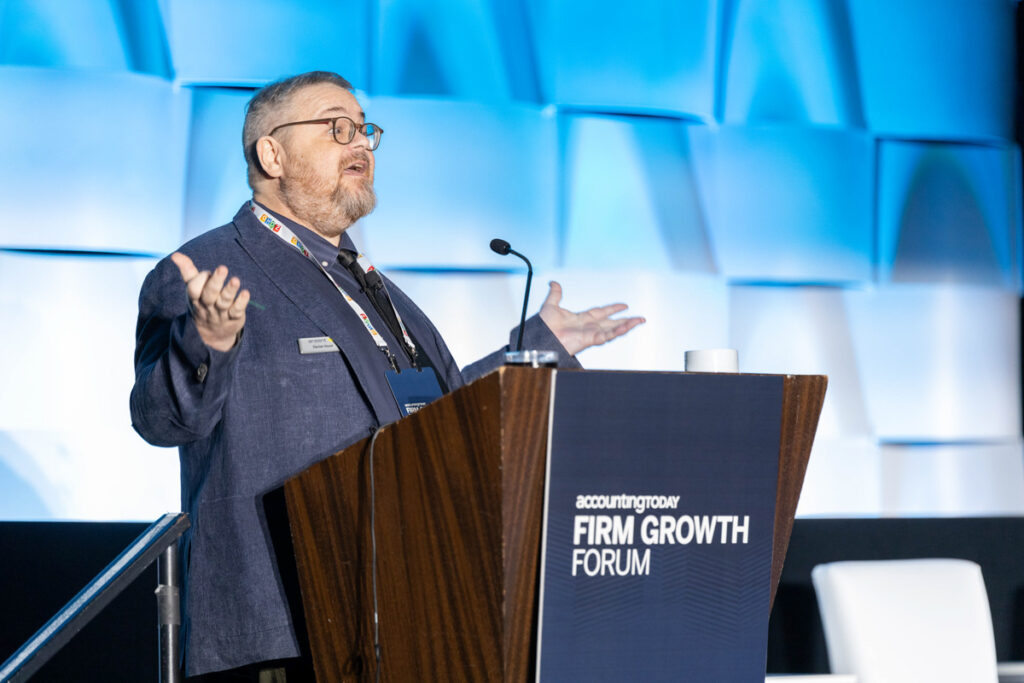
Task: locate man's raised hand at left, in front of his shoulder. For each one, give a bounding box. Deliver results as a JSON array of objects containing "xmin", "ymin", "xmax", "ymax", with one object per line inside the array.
[{"xmin": 171, "ymin": 252, "xmax": 249, "ymax": 351}]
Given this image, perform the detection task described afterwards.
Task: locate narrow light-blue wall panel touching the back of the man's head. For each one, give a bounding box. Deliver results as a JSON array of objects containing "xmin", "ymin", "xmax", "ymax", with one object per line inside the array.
[{"xmin": 182, "ymin": 87, "xmax": 253, "ymax": 242}]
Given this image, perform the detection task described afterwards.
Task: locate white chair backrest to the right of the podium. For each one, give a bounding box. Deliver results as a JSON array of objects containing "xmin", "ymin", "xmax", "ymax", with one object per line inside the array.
[{"xmin": 811, "ymin": 559, "xmax": 998, "ymax": 683}]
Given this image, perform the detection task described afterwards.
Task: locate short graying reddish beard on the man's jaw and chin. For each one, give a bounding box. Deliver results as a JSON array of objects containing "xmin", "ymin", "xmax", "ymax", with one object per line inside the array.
[{"xmin": 281, "ymin": 169, "xmax": 377, "ymax": 238}]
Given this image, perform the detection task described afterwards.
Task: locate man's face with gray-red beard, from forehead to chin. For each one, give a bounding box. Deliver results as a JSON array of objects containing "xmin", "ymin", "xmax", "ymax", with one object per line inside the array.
[{"xmin": 274, "ymin": 83, "xmax": 377, "ymax": 238}]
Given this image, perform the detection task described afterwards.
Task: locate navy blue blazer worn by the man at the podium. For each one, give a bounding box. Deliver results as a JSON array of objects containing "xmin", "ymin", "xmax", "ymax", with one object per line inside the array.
[{"xmin": 130, "ymin": 206, "xmax": 579, "ymax": 676}]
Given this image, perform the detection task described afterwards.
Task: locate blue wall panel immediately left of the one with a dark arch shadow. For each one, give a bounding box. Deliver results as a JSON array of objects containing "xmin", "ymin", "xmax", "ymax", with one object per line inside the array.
[{"xmin": 691, "ymin": 126, "xmax": 874, "ymax": 284}]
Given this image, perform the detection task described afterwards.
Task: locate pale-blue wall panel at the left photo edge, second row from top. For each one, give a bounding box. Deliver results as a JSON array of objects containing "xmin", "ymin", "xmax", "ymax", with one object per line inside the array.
[{"xmin": 0, "ymin": 67, "xmax": 189, "ymax": 252}]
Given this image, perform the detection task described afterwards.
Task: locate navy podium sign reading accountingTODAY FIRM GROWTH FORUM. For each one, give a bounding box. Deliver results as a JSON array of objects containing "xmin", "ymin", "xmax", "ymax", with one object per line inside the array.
[{"xmin": 537, "ymin": 372, "xmax": 783, "ymax": 683}]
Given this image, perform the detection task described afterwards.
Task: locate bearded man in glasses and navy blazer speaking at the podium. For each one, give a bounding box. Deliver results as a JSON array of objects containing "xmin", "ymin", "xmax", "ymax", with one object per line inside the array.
[{"xmin": 131, "ymin": 72, "xmax": 643, "ymax": 680}]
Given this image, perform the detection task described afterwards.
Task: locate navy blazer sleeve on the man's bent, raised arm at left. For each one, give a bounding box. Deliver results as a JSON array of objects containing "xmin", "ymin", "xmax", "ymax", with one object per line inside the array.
[{"xmin": 129, "ymin": 258, "xmax": 244, "ymax": 446}]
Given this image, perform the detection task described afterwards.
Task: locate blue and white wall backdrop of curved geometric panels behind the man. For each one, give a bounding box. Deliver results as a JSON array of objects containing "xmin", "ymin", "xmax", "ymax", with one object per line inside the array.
[{"xmin": 0, "ymin": 0, "xmax": 1024, "ymax": 519}]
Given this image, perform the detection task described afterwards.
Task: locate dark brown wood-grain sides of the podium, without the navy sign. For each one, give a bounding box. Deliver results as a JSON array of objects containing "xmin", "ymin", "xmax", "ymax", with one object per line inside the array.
[{"xmin": 285, "ymin": 367, "xmax": 826, "ymax": 681}]
